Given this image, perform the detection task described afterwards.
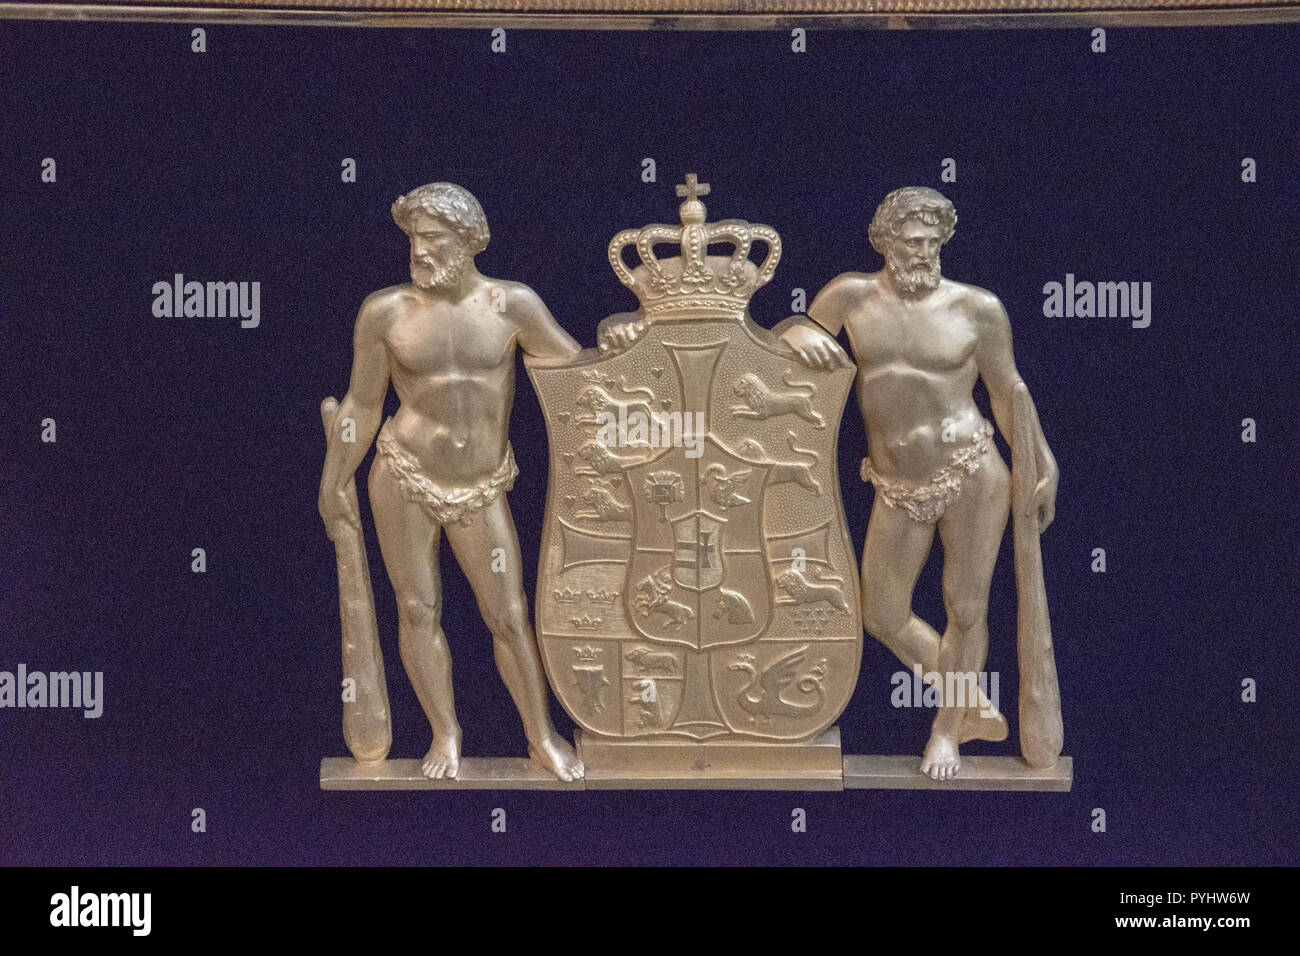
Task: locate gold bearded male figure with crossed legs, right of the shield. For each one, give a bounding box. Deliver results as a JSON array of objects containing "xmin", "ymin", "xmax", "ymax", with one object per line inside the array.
[{"xmin": 781, "ymin": 187, "xmax": 1057, "ymax": 780}]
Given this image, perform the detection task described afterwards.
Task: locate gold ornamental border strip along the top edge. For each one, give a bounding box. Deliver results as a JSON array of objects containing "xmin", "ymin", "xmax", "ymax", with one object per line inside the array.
[{"xmin": 0, "ymin": 0, "xmax": 1300, "ymax": 30}]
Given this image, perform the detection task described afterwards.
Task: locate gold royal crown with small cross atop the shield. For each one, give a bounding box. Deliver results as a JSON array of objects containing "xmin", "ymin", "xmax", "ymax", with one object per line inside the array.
[{"xmin": 610, "ymin": 173, "xmax": 781, "ymax": 321}]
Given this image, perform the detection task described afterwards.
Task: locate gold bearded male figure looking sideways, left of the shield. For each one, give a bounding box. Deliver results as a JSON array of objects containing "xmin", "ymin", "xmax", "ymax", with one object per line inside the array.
[{"xmin": 319, "ymin": 182, "xmax": 582, "ymax": 780}]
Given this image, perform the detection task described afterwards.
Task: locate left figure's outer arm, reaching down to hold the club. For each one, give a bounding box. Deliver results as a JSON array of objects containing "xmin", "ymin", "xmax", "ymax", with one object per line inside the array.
[{"xmin": 317, "ymin": 293, "xmax": 389, "ymax": 537}]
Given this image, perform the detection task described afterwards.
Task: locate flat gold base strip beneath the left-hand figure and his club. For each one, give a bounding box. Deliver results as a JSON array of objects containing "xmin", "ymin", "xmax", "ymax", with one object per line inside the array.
[{"xmin": 321, "ymin": 757, "xmax": 582, "ymax": 790}]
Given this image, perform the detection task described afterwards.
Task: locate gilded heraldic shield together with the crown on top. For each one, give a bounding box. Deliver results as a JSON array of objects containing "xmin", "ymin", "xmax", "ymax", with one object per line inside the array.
[{"xmin": 527, "ymin": 176, "xmax": 862, "ymax": 741}]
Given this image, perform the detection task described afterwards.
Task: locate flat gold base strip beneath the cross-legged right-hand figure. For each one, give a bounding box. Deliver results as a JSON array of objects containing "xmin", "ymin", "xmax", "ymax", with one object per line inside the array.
[{"xmin": 844, "ymin": 754, "xmax": 1074, "ymax": 791}]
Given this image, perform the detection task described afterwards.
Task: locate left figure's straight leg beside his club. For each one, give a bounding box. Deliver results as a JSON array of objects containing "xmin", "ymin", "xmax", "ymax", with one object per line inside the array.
[{"xmin": 369, "ymin": 455, "xmax": 460, "ymax": 778}]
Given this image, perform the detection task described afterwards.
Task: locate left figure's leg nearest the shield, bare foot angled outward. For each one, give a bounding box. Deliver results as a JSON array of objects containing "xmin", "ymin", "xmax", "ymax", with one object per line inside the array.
[{"xmin": 446, "ymin": 496, "xmax": 582, "ymax": 780}]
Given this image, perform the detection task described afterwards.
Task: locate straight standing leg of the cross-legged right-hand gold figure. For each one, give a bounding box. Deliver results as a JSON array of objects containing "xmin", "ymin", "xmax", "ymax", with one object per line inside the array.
[{"xmin": 922, "ymin": 450, "xmax": 1010, "ymax": 779}]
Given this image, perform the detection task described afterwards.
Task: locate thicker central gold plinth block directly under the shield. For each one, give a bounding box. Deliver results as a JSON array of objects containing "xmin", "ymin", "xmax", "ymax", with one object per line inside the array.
[{"xmin": 577, "ymin": 727, "xmax": 844, "ymax": 790}]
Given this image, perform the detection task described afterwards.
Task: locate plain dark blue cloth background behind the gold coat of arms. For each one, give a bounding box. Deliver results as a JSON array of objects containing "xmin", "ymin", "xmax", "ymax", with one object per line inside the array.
[{"xmin": 0, "ymin": 22, "xmax": 1300, "ymax": 865}]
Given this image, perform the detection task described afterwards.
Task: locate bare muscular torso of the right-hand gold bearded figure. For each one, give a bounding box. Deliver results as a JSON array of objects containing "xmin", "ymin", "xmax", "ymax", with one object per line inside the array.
[{"xmin": 826, "ymin": 276, "xmax": 984, "ymax": 481}]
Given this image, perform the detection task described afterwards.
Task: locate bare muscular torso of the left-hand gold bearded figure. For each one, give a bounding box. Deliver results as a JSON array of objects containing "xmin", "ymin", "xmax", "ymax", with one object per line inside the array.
[{"xmin": 384, "ymin": 282, "xmax": 519, "ymax": 486}]
